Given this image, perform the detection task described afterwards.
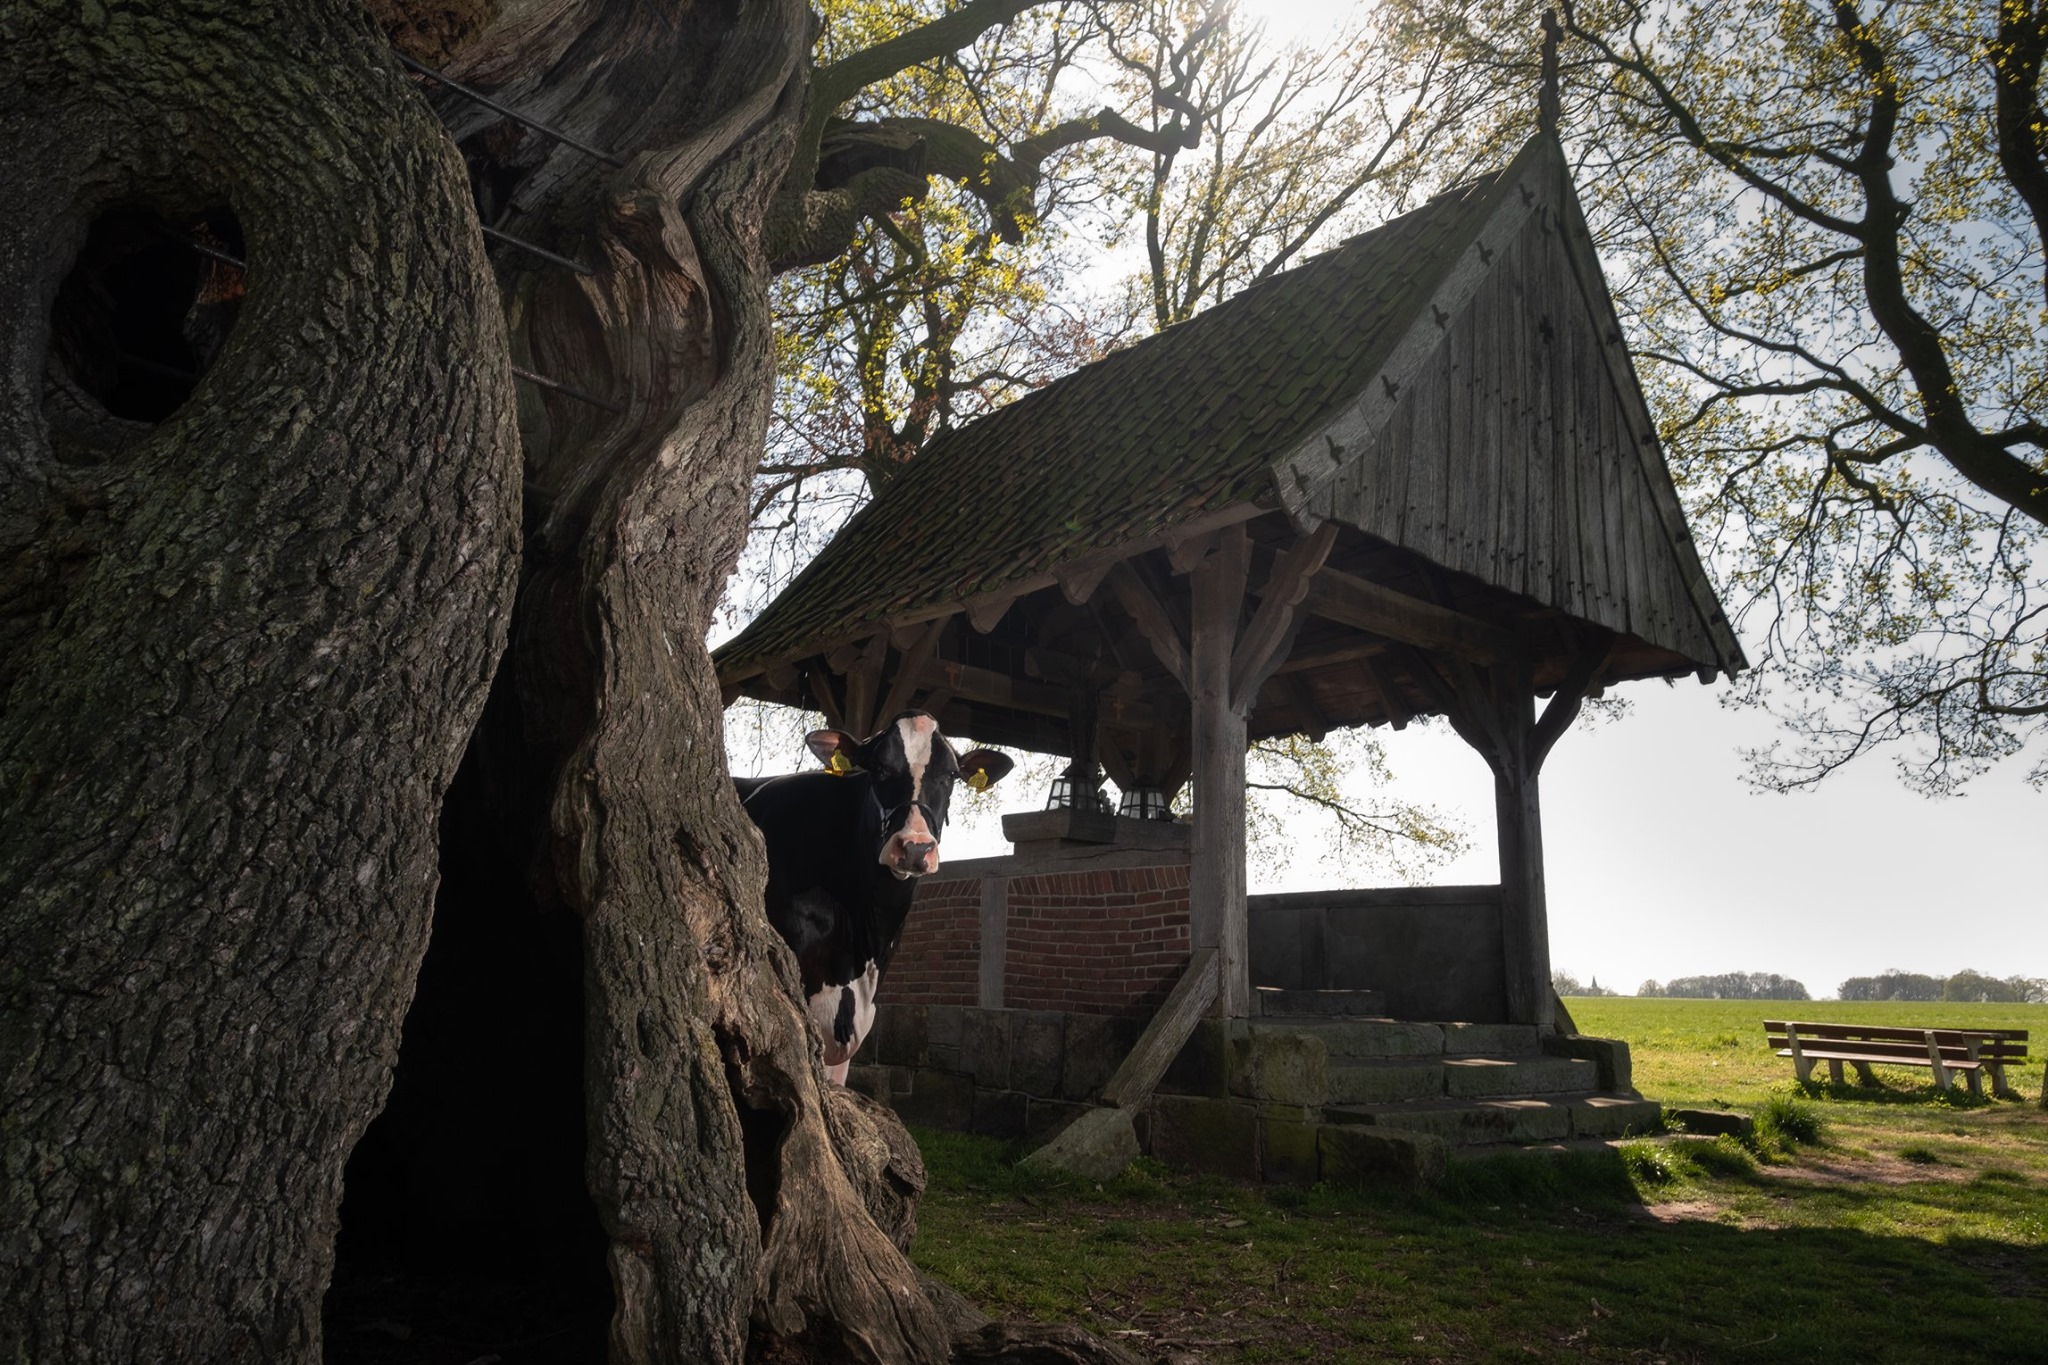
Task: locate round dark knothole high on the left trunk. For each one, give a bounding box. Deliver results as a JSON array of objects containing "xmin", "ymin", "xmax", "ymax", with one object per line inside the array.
[{"xmin": 49, "ymin": 207, "xmax": 244, "ymax": 422}]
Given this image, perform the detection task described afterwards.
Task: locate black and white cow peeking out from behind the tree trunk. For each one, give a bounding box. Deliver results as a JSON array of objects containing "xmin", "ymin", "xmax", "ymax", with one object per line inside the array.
[{"xmin": 733, "ymin": 710, "xmax": 1010, "ymax": 1085}]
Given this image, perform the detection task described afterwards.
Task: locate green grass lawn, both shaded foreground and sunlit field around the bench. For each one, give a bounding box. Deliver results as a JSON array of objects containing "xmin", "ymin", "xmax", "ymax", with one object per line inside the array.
[{"xmin": 915, "ymin": 999, "xmax": 2048, "ymax": 1363}]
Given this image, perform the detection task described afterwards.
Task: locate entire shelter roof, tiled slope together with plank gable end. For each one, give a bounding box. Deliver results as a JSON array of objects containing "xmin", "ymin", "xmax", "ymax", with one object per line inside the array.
[{"xmin": 715, "ymin": 137, "xmax": 1745, "ymax": 724}]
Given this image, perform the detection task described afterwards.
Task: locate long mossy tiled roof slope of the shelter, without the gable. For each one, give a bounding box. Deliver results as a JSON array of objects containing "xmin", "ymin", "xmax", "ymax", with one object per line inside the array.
[{"xmin": 717, "ymin": 151, "xmax": 1528, "ymax": 681}]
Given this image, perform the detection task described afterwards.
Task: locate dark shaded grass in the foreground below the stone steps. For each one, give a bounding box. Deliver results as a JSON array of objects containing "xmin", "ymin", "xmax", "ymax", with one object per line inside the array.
[{"xmin": 915, "ymin": 1132, "xmax": 2048, "ymax": 1365}]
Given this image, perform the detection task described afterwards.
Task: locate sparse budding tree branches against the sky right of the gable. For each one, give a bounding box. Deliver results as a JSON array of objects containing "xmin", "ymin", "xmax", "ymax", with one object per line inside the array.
[{"xmin": 1499, "ymin": 0, "xmax": 2048, "ymax": 792}]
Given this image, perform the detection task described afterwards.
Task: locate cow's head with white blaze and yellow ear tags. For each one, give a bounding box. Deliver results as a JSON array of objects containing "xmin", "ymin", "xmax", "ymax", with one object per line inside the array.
[{"xmin": 805, "ymin": 710, "xmax": 1012, "ymax": 878}]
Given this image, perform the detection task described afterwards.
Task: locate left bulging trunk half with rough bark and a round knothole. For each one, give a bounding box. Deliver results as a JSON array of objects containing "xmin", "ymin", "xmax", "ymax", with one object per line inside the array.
[{"xmin": 0, "ymin": 0, "xmax": 518, "ymax": 1361}]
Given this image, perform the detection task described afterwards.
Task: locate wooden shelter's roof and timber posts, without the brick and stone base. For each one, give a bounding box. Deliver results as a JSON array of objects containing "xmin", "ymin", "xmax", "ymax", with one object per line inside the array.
[{"xmin": 717, "ymin": 137, "xmax": 1743, "ymax": 1025}]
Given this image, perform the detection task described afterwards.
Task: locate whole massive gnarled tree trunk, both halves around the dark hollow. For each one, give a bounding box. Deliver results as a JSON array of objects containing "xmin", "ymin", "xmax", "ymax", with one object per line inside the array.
[{"xmin": 0, "ymin": 0, "xmax": 1126, "ymax": 1363}]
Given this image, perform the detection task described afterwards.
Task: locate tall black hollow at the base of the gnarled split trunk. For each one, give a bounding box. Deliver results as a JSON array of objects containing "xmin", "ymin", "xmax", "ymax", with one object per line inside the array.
[{"xmin": 326, "ymin": 667, "xmax": 612, "ymax": 1365}]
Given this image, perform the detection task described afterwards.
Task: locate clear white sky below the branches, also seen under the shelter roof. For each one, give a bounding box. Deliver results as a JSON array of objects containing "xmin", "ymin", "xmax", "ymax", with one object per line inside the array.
[{"xmin": 921, "ymin": 679, "xmax": 2048, "ymax": 997}]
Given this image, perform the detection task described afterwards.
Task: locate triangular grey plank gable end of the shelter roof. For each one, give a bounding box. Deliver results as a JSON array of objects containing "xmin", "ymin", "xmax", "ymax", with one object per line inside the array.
[{"xmin": 1274, "ymin": 143, "xmax": 1743, "ymax": 671}]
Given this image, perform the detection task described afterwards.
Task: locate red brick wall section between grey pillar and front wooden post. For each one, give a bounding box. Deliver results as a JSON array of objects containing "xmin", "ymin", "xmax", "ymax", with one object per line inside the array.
[{"xmin": 1004, "ymin": 864, "xmax": 1188, "ymax": 1015}]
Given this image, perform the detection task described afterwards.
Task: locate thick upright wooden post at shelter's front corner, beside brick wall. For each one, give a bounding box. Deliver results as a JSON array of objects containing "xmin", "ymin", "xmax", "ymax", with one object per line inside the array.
[{"xmin": 1188, "ymin": 526, "xmax": 1251, "ymax": 1019}]
